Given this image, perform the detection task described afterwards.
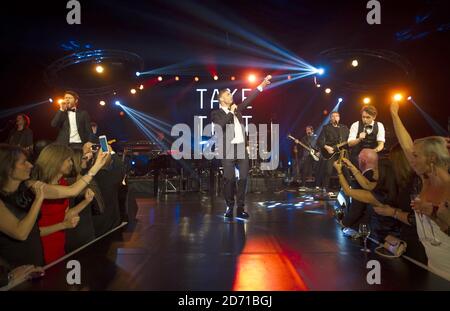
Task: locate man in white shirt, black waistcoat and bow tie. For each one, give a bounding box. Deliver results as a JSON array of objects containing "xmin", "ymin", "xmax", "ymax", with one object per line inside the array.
[{"xmin": 348, "ymin": 105, "xmax": 386, "ymax": 165}]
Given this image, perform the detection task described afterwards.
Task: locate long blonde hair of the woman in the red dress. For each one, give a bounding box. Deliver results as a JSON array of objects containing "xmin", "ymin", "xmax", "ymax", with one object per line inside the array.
[{"xmin": 31, "ymin": 144, "xmax": 73, "ymax": 183}]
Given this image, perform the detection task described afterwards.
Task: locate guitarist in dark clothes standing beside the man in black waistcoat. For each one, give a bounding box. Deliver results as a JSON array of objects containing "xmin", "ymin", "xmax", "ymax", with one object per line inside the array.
[{"xmin": 317, "ymin": 111, "xmax": 349, "ymax": 191}]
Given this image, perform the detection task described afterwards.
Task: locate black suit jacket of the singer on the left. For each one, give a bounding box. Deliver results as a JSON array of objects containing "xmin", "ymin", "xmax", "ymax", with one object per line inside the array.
[{"xmin": 51, "ymin": 109, "xmax": 94, "ymax": 145}]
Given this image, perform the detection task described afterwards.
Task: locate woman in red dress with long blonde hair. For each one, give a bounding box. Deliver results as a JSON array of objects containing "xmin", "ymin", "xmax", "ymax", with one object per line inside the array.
[{"xmin": 34, "ymin": 144, "xmax": 94, "ymax": 264}]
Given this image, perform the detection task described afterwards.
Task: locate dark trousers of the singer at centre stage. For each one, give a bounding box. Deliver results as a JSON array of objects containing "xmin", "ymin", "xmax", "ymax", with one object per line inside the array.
[{"xmin": 222, "ymin": 145, "xmax": 249, "ymax": 213}]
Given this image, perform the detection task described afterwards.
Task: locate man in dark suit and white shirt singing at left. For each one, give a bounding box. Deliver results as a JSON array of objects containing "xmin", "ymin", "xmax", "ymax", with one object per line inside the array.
[{"xmin": 51, "ymin": 91, "xmax": 93, "ymax": 149}]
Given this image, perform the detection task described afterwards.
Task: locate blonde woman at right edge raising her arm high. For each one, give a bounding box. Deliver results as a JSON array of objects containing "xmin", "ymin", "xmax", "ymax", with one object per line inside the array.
[{"xmin": 391, "ymin": 102, "xmax": 450, "ymax": 280}]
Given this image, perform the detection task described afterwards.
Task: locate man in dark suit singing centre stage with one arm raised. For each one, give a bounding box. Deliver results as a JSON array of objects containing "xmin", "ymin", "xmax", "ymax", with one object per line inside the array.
[{"xmin": 211, "ymin": 75, "xmax": 271, "ymax": 218}]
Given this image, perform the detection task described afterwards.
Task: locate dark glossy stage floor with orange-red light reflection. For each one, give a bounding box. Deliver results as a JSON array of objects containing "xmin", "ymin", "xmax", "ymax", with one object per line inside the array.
[{"xmin": 16, "ymin": 191, "xmax": 450, "ymax": 291}]
